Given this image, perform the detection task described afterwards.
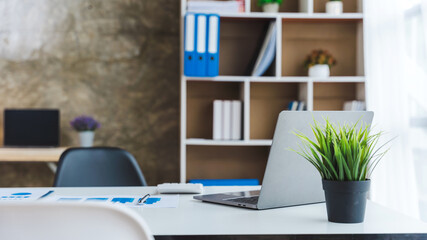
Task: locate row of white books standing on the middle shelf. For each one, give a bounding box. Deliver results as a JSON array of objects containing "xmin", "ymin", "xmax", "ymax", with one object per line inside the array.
[{"xmin": 212, "ymin": 100, "xmax": 242, "ymax": 140}]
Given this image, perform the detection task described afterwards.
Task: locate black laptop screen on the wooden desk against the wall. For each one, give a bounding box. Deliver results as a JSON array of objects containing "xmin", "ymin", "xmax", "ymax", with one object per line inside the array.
[{"xmin": 4, "ymin": 109, "xmax": 59, "ymax": 147}]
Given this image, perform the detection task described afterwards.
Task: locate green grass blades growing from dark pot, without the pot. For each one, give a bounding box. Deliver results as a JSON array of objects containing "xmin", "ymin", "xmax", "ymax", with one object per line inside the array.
[{"xmin": 291, "ymin": 119, "xmax": 391, "ymax": 181}]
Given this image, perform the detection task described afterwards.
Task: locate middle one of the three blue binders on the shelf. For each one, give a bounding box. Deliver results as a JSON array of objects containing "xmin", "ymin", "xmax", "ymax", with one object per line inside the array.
[{"xmin": 194, "ymin": 13, "xmax": 208, "ymax": 77}]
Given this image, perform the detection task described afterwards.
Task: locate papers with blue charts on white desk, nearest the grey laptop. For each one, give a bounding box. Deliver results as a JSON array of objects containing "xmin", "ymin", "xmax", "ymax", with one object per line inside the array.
[{"xmin": 46, "ymin": 195, "xmax": 179, "ymax": 208}]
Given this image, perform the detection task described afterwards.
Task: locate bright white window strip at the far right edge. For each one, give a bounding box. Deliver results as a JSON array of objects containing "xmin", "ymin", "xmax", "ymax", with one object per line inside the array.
[{"xmin": 404, "ymin": 0, "xmax": 427, "ymax": 221}]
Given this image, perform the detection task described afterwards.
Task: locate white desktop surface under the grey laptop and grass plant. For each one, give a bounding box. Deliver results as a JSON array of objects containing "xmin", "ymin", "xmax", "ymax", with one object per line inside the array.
[{"xmin": 5, "ymin": 187, "xmax": 427, "ymax": 236}]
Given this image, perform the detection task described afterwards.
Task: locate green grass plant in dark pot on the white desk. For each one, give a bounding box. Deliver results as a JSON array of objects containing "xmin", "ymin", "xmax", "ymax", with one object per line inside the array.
[{"xmin": 294, "ymin": 120, "xmax": 388, "ymax": 223}]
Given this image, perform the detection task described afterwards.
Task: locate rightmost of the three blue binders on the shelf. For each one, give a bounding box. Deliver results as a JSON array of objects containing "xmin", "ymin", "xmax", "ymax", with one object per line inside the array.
[{"xmin": 206, "ymin": 14, "xmax": 220, "ymax": 77}]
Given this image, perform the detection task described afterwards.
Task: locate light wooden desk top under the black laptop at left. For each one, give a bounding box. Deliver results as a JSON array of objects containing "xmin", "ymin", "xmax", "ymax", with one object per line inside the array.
[{"xmin": 0, "ymin": 147, "xmax": 67, "ymax": 162}]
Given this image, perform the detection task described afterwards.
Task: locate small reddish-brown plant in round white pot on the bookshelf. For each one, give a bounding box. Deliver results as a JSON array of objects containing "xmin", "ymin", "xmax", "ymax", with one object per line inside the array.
[{"xmin": 304, "ymin": 49, "xmax": 337, "ymax": 77}]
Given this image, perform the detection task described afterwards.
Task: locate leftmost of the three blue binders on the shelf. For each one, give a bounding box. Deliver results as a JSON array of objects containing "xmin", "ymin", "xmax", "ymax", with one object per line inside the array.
[{"xmin": 184, "ymin": 13, "xmax": 196, "ymax": 76}]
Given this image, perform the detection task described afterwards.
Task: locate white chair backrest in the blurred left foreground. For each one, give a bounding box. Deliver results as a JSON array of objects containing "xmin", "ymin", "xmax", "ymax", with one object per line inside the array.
[{"xmin": 0, "ymin": 202, "xmax": 154, "ymax": 240}]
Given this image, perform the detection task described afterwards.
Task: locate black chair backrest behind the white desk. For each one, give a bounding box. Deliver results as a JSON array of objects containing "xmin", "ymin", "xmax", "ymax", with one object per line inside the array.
[{"xmin": 53, "ymin": 147, "xmax": 147, "ymax": 187}]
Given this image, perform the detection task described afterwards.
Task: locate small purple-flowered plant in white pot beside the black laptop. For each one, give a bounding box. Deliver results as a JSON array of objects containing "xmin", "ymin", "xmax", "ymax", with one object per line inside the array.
[{"xmin": 70, "ymin": 116, "xmax": 101, "ymax": 147}]
